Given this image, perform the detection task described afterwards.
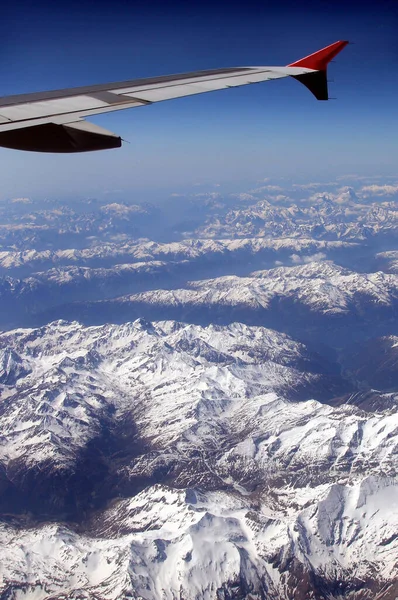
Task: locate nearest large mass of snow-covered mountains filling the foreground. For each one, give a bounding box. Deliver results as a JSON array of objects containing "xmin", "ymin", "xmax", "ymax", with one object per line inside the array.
[{"xmin": 0, "ymin": 320, "xmax": 398, "ymax": 600}]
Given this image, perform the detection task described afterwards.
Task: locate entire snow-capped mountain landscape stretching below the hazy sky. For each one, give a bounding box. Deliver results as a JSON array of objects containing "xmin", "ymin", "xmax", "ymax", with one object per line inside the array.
[{"xmin": 0, "ymin": 182, "xmax": 398, "ymax": 600}]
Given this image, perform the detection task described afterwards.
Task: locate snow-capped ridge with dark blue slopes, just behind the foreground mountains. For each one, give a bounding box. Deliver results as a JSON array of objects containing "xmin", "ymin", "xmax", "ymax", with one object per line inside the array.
[{"xmin": 30, "ymin": 261, "xmax": 398, "ymax": 349}]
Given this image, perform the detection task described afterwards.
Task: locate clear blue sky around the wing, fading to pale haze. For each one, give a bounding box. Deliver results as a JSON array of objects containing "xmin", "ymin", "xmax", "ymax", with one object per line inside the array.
[{"xmin": 0, "ymin": 0, "xmax": 398, "ymax": 200}]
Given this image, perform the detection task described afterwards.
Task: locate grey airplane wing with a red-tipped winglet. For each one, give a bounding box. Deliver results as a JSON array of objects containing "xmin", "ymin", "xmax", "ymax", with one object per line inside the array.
[{"xmin": 0, "ymin": 41, "xmax": 348, "ymax": 152}]
